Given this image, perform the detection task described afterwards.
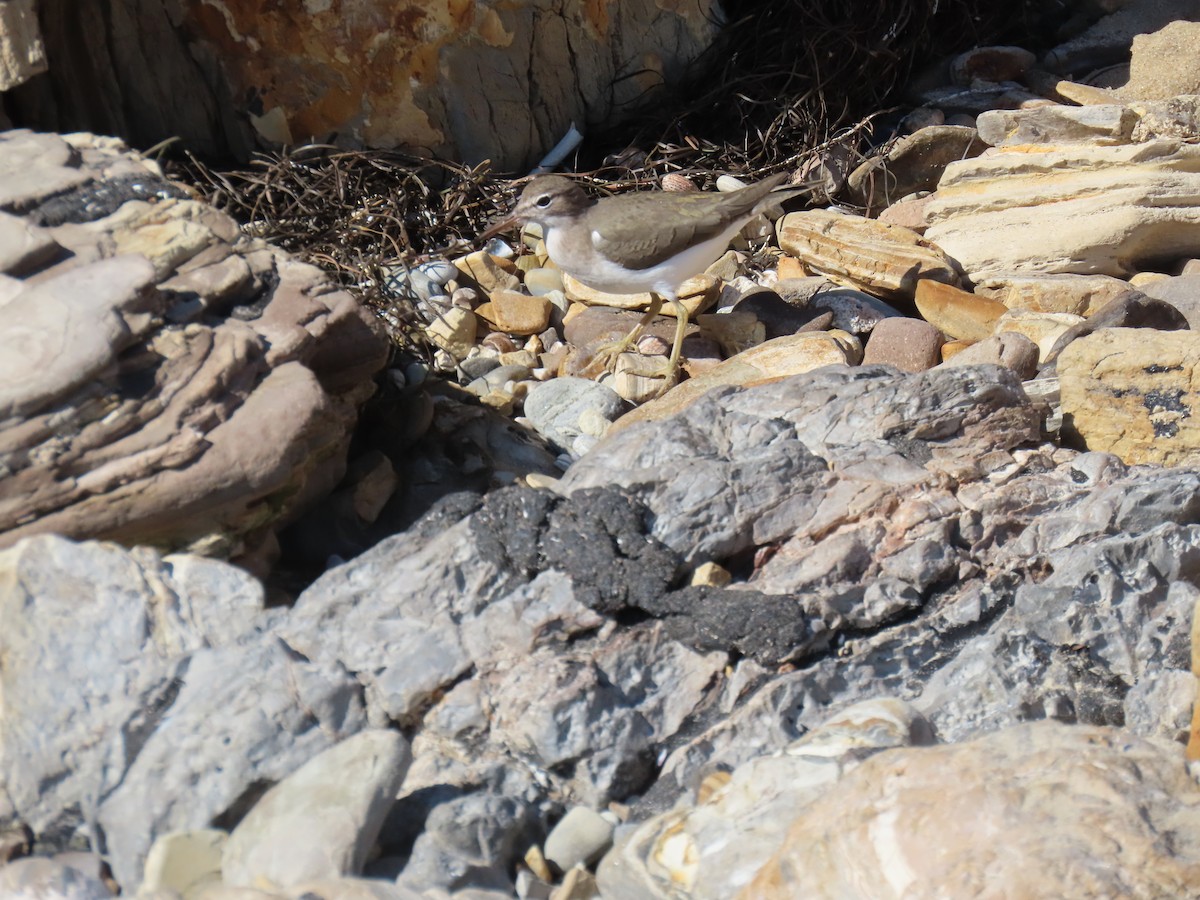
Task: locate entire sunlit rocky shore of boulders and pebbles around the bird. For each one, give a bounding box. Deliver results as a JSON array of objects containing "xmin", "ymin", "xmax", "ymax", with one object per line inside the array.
[{"xmin": 0, "ymin": 2, "xmax": 1200, "ymax": 900}]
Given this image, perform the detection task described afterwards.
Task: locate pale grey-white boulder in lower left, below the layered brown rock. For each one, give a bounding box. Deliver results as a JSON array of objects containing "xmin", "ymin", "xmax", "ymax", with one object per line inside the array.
[{"xmin": 0, "ymin": 536, "xmax": 365, "ymax": 890}]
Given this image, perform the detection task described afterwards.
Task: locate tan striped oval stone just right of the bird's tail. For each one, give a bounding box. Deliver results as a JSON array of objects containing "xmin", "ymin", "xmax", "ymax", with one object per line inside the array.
[{"xmin": 776, "ymin": 210, "xmax": 959, "ymax": 298}]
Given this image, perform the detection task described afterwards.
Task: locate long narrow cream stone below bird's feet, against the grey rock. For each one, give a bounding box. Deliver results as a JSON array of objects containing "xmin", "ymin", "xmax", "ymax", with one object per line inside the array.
[{"xmin": 610, "ymin": 331, "xmax": 863, "ymax": 433}]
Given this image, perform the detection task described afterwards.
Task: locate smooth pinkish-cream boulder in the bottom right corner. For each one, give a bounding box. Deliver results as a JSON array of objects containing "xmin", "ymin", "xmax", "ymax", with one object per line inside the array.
[{"xmin": 737, "ymin": 722, "xmax": 1200, "ymax": 900}]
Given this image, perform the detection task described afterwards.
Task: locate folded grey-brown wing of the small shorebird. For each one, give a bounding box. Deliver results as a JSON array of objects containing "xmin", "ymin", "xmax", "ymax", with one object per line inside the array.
[{"xmin": 588, "ymin": 173, "xmax": 787, "ymax": 269}]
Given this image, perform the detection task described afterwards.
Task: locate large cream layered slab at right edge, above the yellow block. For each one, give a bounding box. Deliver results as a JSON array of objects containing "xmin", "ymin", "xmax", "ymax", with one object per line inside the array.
[{"xmin": 925, "ymin": 140, "xmax": 1200, "ymax": 281}]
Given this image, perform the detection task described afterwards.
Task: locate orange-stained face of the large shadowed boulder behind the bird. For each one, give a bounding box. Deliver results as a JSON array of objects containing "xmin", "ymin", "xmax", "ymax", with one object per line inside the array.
[{"xmin": 178, "ymin": 0, "xmax": 720, "ymax": 170}]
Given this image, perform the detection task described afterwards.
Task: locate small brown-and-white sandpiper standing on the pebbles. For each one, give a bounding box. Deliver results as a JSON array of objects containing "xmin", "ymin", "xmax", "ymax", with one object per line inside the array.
[{"xmin": 487, "ymin": 173, "xmax": 787, "ymax": 386}]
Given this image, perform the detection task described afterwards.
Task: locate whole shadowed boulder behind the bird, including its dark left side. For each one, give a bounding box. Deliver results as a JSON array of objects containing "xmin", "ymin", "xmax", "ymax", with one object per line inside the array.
[{"xmin": 14, "ymin": 0, "xmax": 721, "ymax": 170}]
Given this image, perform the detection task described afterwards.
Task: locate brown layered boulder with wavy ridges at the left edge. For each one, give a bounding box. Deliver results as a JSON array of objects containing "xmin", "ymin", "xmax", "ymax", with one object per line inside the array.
[{"xmin": 0, "ymin": 132, "xmax": 386, "ymax": 554}]
